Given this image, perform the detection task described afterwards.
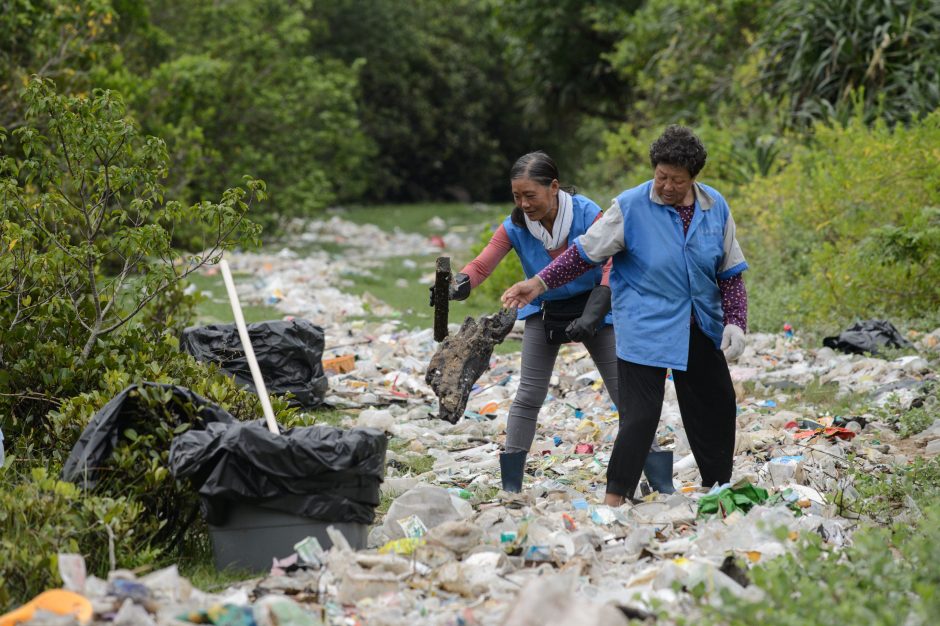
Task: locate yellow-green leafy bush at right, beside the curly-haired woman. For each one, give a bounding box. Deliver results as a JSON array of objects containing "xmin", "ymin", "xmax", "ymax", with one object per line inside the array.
[{"xmin": 734, "ymin": 110, "xmax": 940, "ymax": 330}]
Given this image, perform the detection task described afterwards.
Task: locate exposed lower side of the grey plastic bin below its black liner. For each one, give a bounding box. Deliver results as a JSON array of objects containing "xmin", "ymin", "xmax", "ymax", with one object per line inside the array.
[{"xmin": 209, "ymin": 502, "xmax": 369, "ymax": 572}]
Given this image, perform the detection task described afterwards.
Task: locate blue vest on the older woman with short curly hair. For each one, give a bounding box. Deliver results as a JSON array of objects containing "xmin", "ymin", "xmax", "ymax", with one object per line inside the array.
[{"xmin": 610, "ymin": 181, "xmax": 730, "ymax": 371}]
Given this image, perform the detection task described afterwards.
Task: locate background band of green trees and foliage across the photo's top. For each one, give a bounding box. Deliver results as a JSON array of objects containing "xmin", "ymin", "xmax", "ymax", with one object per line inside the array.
[{"xmin": 0, "ymin": 0, "xmax": 940, "ymax": 219}]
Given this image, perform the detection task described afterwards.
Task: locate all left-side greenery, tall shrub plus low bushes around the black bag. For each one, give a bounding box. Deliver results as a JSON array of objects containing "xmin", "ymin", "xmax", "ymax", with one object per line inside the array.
[{"xmin": 0, "ymin": 79, "xmax": 288, "ymax": 609}]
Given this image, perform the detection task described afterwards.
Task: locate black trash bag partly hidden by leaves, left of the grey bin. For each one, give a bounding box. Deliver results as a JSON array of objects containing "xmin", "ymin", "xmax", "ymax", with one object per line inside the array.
[{"xmin": 62, "ymin": 383, "xmax": 236, "ymax": 489}]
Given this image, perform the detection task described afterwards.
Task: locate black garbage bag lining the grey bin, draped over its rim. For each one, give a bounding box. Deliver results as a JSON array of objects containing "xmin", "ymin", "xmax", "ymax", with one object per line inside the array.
[{"xmin": 170, "ymin": 421, "xmax": 388, "ymax": 525}]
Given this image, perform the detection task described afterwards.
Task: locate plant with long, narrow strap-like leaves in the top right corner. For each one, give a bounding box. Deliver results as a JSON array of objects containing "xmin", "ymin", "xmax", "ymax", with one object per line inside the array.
[{"xmin": 757, "ymin": 0, "xmax": 940, "ymax": 125}]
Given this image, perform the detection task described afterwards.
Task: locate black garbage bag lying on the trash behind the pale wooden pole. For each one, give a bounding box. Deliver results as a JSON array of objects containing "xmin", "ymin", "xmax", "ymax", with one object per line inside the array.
[{"xmin": 180, "ymin": 318, "xmax": 328, "ymax": 409}]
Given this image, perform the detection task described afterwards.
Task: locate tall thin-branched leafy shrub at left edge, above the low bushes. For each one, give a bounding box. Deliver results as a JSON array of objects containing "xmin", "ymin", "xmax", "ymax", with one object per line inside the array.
[{"xmin": 0, "ymin": 78, "xmax": 264, "ymax": 437}]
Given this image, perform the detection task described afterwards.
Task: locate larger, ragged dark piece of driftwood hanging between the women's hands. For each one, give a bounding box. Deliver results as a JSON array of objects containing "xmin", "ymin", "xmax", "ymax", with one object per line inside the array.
[{"xmin": 424, "ymin": 309, "xmax": 516, "ymax": 424}]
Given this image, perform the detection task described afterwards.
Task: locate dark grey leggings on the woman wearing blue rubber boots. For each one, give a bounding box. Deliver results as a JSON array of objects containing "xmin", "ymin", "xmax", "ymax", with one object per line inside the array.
[{"xmin": 506, "ymin": 315, "xmax": 620, "ymax": 452}]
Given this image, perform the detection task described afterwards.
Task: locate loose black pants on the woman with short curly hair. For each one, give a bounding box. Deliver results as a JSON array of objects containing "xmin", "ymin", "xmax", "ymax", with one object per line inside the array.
[{"xmin": 607, "ymin": 324, "xmax": 737, "ymax": 497}]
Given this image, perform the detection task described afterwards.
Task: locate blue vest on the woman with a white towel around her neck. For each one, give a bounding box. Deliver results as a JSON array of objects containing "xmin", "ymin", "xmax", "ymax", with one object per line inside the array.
[{"xmin": 503, "ymin": 195, "xmax": 613, "ymax": 324}]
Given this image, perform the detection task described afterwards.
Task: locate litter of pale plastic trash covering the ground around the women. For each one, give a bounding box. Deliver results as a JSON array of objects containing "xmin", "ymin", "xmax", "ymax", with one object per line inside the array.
[{"xmin": 9, "ymin": 212, "xmax": 940, "ymax": 626}]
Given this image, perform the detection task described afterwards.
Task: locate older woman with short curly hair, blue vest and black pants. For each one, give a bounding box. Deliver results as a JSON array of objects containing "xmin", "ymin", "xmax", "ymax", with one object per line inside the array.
[{"xmin": 503, "ymin": 126, "xmax": 747, "ymax": 505}]
